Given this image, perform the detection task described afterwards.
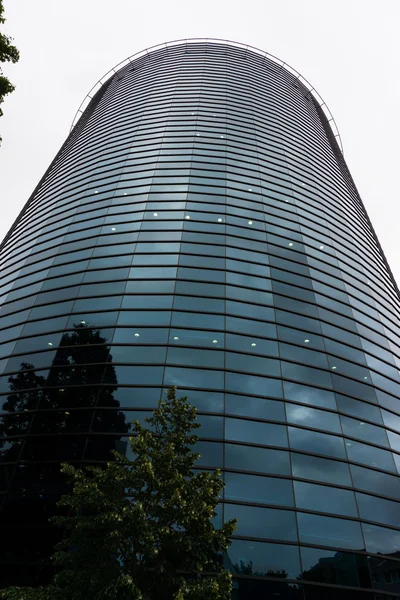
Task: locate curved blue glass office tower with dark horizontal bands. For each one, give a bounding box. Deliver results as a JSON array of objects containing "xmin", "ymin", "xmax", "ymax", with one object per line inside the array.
[{"xmin": 0, "ymin": 40, "xmax": 400, "ymax": 600}]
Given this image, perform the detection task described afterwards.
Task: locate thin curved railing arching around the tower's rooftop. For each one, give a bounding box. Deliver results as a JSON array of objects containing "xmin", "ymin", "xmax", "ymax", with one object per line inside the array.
[{"xmin": 70, "ymin": 38, "xmax": 343, "ymax": 154}]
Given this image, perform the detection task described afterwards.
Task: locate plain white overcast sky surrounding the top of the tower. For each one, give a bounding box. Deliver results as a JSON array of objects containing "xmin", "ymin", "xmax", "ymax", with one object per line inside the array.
[{"xmin": 0, "ymin": 0, "xmax": 400, "ymax": 283}]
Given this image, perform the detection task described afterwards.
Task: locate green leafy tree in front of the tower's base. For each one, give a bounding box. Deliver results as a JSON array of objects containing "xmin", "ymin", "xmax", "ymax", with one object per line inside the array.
[{"xmin": 2, "ymin": 388, "xmax": 236, "ymax": 600}]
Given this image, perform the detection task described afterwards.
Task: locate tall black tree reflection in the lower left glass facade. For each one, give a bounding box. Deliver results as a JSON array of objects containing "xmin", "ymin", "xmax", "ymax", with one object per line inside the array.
[{"xmin": 0, "ymin": 324, "xmax": 130, "ymax": 588}]
